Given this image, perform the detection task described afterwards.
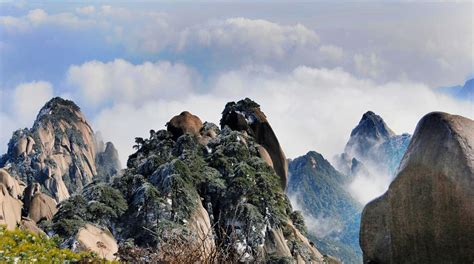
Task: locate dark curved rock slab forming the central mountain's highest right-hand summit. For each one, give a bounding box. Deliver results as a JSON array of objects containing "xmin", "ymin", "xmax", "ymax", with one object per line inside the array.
[{"xmin": 220, "ymin": 98, "xmax": 288, "ymax": 189}]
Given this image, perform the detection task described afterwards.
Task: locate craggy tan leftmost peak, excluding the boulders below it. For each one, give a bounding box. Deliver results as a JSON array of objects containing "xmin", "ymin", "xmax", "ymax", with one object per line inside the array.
[{"xmin": 0, "ymin": 97, "xmax": 121, "ymax": 202}]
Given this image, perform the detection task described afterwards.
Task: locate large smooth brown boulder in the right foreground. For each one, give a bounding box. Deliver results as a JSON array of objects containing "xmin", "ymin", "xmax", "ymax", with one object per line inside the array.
[{"xmin": 360, "ymin": 112, "xmax": 474, "ymax": 263}]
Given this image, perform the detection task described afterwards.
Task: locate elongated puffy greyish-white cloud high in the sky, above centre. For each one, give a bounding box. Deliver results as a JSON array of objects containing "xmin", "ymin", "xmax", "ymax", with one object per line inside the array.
[{"xmin": 178, "ymin": 17, "xmax": 319, "ymax": 60}]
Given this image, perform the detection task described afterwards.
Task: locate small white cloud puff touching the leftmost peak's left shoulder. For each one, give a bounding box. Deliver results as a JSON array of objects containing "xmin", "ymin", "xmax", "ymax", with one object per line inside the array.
[{"xmin": 13, "ymin": 81, "xmax": 53, "ymax": 128}]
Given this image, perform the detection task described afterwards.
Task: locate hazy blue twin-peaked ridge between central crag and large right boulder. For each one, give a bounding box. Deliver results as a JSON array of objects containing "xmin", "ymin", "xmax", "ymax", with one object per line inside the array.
[{"xmin": 288, "ymin": 111, "xmax": 410, "ymax": 263}]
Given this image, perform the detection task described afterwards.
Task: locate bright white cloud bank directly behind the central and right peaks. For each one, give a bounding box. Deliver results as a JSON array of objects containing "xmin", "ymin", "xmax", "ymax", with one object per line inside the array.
[{"xmin": 70, "ymin": 61, "xmax": 474, "ymax": 169}]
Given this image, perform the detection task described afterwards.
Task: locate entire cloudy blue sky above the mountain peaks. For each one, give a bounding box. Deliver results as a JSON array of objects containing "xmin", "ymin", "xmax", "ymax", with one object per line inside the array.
[{"xmin": 0, "ymin": 1, "xmax": 474, "ymax": 167}]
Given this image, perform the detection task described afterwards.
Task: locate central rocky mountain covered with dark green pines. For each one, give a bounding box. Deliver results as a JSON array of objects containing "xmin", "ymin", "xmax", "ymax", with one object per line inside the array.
[{"xmin": 50, "ymin": 99, "xmax": 330, "ymax": 263}]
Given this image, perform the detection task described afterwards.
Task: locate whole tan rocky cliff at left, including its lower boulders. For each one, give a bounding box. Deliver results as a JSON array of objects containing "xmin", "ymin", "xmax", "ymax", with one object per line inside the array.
[{"xmin": 0, "ymin": 98, "xmax": 120, "ymax": 249}]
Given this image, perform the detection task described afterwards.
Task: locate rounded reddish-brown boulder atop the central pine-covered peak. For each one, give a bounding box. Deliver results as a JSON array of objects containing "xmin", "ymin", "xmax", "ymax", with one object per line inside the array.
[{"xmin": 166, "ymin": 111, "xmax": 203, "ymax": 139}]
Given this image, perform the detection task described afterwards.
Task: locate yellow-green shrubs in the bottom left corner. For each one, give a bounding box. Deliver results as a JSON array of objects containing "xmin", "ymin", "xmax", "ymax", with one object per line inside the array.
[{"xmin": 0, "ymin": 226, "xmax": 98, "ymax": 263}]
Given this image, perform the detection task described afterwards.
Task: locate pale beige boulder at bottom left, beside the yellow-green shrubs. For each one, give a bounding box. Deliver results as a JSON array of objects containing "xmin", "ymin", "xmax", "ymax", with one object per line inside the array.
[{"xmin": 76, "ymin": 224, "xmax": 118, "ymax": 260}]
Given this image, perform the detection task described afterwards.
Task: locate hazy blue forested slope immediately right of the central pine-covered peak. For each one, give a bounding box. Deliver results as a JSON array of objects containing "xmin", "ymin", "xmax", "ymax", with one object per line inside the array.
[{"xmin": 288, "ymin": 151, "xmax": 362, "ymax": 263}]
